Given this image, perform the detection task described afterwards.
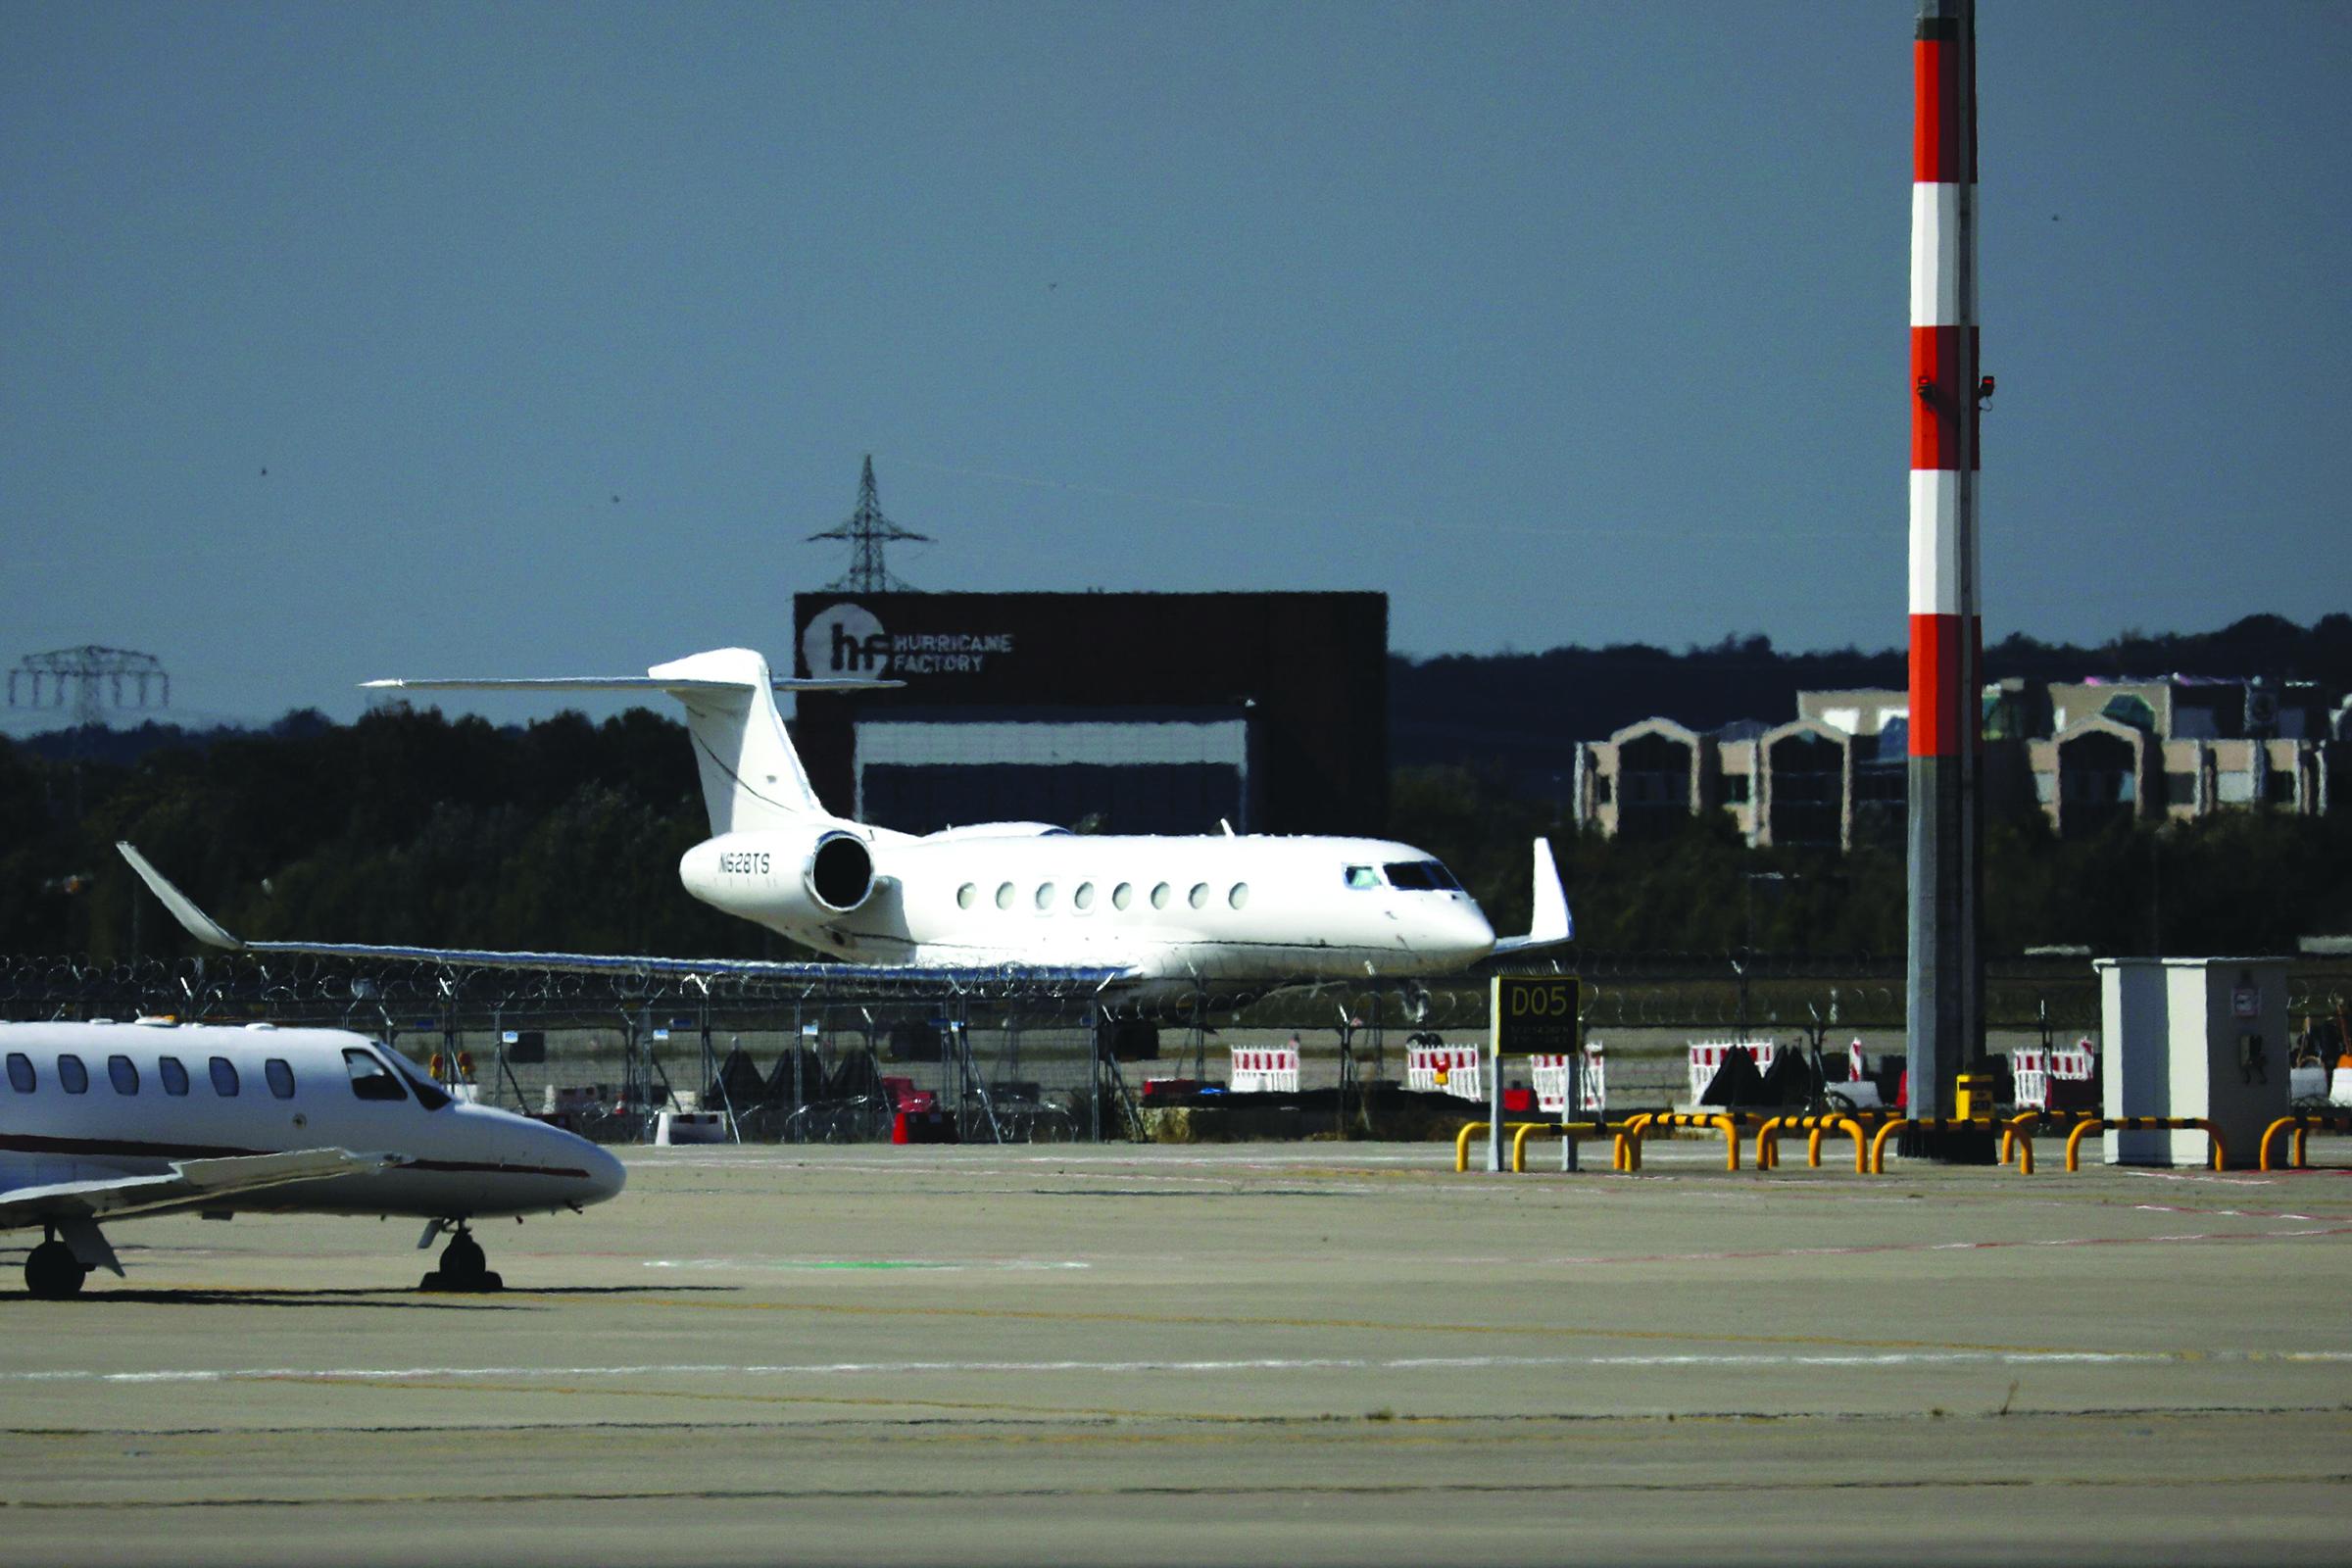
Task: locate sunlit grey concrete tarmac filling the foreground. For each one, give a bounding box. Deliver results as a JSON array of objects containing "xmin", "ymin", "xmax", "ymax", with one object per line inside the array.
[{"xmin": 0, "ymin": 1140, "xmax": 2352, "ymax": 1563}]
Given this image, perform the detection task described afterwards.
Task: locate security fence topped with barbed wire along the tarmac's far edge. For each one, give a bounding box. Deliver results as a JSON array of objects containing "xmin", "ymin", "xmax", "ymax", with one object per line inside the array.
[{"xmin": 0, "ymin": 950, "xmax": 2352, "ymax": 1143}]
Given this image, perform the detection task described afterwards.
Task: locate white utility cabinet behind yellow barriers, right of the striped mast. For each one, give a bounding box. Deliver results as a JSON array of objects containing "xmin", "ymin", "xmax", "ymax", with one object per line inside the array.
[{"xmin": 2093, "ymin": 959, "xmax": 2291, "ymax": 1168}]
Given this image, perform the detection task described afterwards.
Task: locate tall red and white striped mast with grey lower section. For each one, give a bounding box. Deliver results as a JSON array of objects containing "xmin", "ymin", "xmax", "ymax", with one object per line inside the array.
[{"xmin": 1905, "ymin": 0, "xmax": 1992, "ymax": 1119}]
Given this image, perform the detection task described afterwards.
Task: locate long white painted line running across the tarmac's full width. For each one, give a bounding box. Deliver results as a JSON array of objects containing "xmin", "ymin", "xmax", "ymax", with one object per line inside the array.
[{"xmin": 18, "ymin": 1349, "xmax": 2352, "ymax": 1385}]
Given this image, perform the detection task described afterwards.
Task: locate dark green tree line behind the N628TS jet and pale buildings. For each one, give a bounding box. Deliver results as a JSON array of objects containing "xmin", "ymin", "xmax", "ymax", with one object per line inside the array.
[{"xmin": 0, "ymin": 615, "xmax": 2352, "ymax": 956}]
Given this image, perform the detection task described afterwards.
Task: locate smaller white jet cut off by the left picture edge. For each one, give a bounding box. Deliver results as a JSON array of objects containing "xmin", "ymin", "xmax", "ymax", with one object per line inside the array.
[{"xmin": 0, "ymin": 1018, "xmax": 625, "ymax": 1298}]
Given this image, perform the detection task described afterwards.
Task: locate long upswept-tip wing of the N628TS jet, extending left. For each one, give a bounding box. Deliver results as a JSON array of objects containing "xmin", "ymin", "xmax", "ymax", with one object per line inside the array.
[{"xmin": 116, "ymin": 842, "xmax": 1143, "ymax": 990}]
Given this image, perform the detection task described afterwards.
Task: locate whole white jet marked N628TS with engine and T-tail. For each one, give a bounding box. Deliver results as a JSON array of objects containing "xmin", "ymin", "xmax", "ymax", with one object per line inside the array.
[{"xmin": 120, "ymin": 649, "xmax": 1571, "ymax": 1002}]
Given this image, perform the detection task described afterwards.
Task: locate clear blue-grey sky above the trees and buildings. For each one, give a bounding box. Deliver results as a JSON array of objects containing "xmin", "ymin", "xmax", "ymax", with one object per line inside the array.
[{"xmin": 0, "ymin": 0, "xmax": 2352, "ymax": 717}]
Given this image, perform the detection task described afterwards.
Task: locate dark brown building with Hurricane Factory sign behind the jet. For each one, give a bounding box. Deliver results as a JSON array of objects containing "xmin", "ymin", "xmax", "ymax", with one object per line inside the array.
[{"xmin": 793, "ymin": 592, "xmax": 1388, "ymax": 835}]
